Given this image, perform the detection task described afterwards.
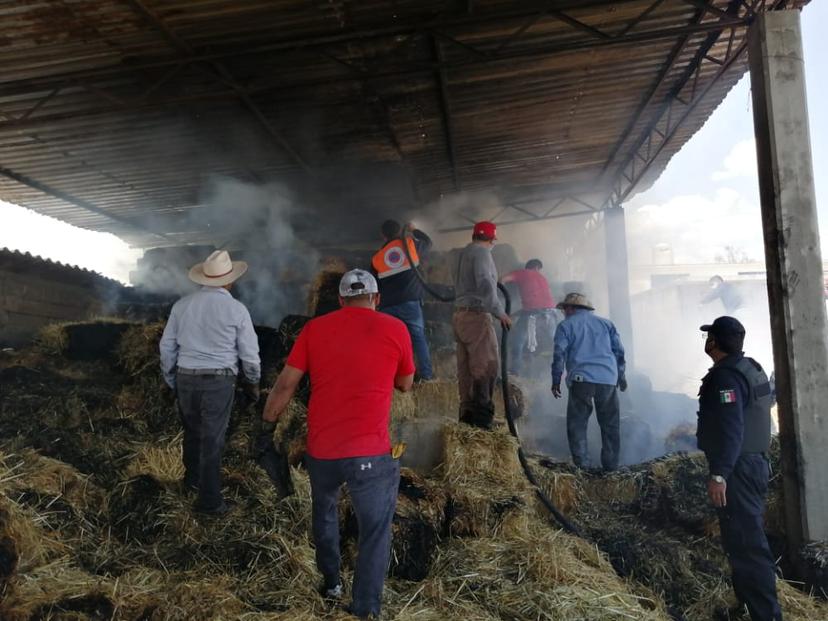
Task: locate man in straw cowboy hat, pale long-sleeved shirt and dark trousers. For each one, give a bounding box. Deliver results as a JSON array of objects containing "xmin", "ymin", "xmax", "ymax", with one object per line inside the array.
[{"xmin": 160, "ymin": 250, "xmax": 261, "ymax": 515}]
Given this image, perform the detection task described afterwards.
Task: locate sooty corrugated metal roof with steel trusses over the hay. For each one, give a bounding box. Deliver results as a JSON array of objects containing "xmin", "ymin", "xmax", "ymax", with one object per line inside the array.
[{"xmin": 0, "ymin": 0, "xmax": 805, "ymax": 246}]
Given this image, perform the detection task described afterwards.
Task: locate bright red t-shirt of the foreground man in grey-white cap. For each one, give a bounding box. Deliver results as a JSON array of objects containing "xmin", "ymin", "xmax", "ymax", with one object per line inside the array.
[{"xmin": 287, "ymin": 306, "xmax": 414, "ymax": 459}]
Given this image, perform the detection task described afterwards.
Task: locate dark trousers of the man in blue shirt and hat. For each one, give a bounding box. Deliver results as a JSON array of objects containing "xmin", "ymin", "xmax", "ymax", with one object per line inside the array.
[{"xmin": 566, "ymin": 382, "xmax": 621, "ymax": 470}]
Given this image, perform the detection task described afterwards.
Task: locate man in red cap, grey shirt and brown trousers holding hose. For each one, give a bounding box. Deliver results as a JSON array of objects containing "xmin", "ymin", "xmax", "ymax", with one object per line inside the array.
[{"xmin": 452, "ymin": 221, "xmax": 512, "ymax": 429}]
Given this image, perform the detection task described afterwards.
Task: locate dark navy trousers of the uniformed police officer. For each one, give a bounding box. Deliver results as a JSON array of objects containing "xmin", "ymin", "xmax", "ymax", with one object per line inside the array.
[{"xmin": 719, "ymin": 453, "xmax": 782, "ymax": 621}]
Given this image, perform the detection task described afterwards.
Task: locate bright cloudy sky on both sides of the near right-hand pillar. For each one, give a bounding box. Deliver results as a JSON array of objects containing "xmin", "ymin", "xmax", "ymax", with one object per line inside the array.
[{"xmin": 625, "ymin": 0, "xmax": 828, "ymax": 265}]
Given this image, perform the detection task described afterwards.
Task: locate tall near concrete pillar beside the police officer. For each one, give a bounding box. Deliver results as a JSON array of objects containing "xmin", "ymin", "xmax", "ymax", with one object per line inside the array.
[{"xmin": 745, "ymin": 11, "xmax": 828, "ymax": 550}]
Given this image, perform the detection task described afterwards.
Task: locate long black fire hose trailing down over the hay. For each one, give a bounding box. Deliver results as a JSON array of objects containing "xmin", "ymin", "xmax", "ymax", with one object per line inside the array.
[{"xmin": 401, "ymin": 234, "xmax": 581, "ymax": 536}]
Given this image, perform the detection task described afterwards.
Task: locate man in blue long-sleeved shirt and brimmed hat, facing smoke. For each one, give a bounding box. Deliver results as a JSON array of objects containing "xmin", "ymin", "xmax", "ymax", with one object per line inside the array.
[{"xmin": 552, "ymin": 293, "xmax": 627, "ymax": 471}]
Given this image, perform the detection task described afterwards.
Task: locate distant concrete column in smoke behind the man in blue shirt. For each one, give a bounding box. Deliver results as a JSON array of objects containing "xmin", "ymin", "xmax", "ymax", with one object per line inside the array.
[{"xmin": 604, "ymin": 207, "xmax": 633, "ymax": 369}]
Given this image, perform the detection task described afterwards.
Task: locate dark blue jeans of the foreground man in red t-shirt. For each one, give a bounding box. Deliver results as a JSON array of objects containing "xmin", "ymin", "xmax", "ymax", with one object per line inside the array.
[{"xmin": 305, "ymin": 455, "xmax": 400, "ymax": 617}]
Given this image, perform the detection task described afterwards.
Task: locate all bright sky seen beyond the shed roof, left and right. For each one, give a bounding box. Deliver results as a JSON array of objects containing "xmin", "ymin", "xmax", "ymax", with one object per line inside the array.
[{"xmin": 0, "ymin": 0, "xmax": 828, "ymax": 283}]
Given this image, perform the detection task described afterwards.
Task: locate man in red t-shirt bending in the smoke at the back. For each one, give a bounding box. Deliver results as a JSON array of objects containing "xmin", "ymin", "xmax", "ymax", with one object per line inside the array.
[{"xmin": 503, "ymin": 259, "xmax": 559, "ymax": 375}]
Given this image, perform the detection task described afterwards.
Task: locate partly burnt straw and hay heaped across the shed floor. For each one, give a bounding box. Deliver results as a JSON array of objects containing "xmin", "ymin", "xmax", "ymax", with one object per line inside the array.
[{"xmin": 6, "ymin": 318, "xmax": 828, "ymax": 621}]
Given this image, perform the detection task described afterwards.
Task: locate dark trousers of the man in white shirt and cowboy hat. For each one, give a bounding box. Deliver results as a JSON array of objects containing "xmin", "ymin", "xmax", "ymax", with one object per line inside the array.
[{"xmin": 176, "ymin": 373, "xmax": 236, "ymax": 509}]
